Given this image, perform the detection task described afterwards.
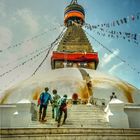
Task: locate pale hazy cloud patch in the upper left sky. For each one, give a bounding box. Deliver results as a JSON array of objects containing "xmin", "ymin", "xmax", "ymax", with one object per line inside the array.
[{"xmin": 17, "ymin": 9, "xmax": 39, "ymax": 34}]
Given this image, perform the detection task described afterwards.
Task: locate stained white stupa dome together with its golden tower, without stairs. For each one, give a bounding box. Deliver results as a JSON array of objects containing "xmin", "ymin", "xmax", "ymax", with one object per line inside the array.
[{"xmin": 0, "ymin": 0, "xmax": 140, "ymax": 104}]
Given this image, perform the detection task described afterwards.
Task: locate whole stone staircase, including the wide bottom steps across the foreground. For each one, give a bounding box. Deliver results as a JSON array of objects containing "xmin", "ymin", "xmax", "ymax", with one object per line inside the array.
[{"xmin": 0, "ymin": 104, "xmax": 140, "ymax": 140}]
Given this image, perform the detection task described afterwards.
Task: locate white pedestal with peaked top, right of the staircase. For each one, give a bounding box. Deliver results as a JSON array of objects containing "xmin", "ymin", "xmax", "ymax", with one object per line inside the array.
[{"xmin": 105, "ymin": 99, "xmax": 129, "ymax": 128}]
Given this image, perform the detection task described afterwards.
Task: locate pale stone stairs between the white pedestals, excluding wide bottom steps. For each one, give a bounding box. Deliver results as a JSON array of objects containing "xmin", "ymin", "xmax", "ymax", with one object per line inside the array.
[{"xmin": 29, "ymin": 104, "xmax": 110, "ymax": 128}]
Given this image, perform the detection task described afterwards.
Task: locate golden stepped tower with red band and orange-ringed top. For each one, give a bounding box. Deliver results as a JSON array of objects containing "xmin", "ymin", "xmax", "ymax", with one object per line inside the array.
[{"xmin": 51, "ymin": 0, "xmax": 99, "ymax": 69}]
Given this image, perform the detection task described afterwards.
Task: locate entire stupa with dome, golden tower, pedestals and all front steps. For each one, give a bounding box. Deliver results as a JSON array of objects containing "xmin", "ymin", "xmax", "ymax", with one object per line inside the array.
[{"xmin": 0, "ymin": 0, "xmax": 140, "ymax": 140}]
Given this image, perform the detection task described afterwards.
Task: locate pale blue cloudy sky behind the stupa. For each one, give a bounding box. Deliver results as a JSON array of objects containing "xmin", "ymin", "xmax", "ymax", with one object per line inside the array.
[{"xmin": 0, "ymin": 0, "xmax": 140, "ymax": 92}]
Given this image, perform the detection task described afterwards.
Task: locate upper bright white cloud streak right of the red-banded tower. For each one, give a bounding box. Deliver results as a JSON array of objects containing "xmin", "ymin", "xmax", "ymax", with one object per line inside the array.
[{"xmin": 101, "ymin": 49, "xmax": 120, "ymax": 67}]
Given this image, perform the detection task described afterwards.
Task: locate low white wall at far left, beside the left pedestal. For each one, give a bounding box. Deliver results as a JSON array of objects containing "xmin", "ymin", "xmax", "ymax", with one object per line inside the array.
[{"xmin": 0, "ymin": 104, "xmax": 16, "ymax": 128}]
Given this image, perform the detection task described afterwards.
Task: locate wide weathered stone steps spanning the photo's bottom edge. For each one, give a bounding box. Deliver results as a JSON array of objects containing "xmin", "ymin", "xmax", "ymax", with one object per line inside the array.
[{"xmin": 0, "ymin": 128, "xmax": 140, "ymax": 140}]
